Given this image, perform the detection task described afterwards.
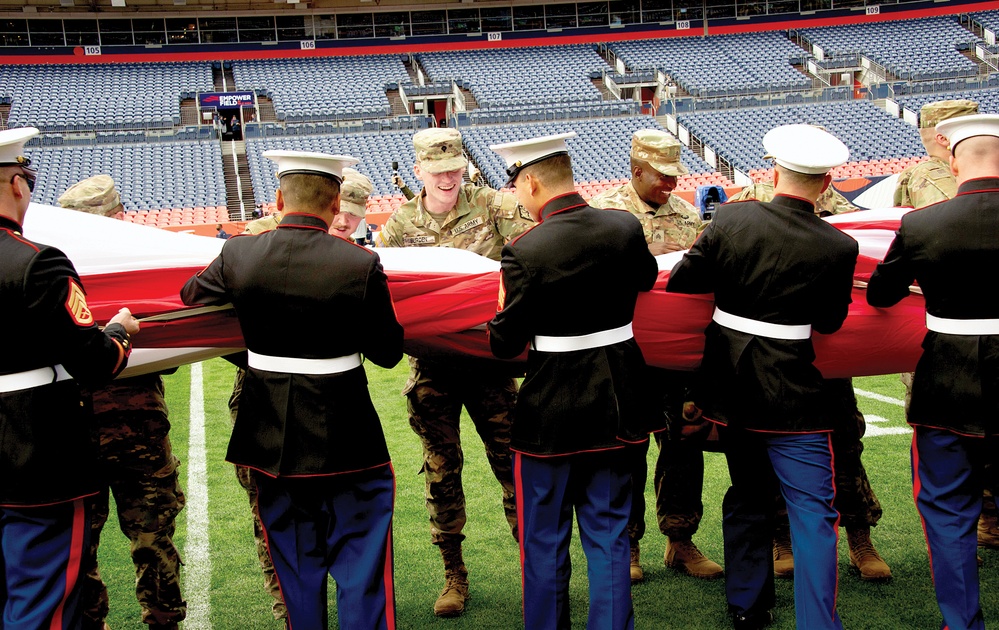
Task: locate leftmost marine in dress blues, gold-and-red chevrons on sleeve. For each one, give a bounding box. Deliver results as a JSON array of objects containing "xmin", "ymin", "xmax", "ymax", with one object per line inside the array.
[{"xmin": 0, "ymin": 127, "xmax": 139, "ymax": 630}]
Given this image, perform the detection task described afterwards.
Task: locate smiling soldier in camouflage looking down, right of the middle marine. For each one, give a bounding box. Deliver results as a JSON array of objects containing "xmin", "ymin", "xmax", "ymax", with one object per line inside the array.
[{"xmin": 589, "ymin": 129, "xmax": 723, "ymax": 582}]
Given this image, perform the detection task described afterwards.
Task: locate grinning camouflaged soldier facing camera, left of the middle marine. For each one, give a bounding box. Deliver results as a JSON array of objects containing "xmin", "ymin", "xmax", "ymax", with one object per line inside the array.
[{"xmin": 379, "ymin": 128, "xmax": 534, "ymax": 617}]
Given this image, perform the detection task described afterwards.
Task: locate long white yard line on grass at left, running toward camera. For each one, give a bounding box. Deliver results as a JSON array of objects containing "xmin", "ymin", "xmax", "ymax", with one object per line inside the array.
[{"xmin": 184, "ymin": 363, "xmax": 212, "ymax": 630}]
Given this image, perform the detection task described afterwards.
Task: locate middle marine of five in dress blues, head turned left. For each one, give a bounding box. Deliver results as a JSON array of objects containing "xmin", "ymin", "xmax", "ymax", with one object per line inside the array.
[{"xmin": 488, "ymin": 134, "xmax": 658, "ymax": 630}]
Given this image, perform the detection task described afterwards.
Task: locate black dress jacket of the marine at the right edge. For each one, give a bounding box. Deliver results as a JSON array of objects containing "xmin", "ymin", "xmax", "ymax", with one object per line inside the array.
[{"xmin": 867, "ymin": 178, "xmax": 999, "ymax": 436}]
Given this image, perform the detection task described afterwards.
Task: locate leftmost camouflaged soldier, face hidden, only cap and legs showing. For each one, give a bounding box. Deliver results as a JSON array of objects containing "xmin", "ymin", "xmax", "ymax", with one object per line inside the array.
[{"xmin": 59, "ymin": 175, "xmax": 187, "ymax": 629}]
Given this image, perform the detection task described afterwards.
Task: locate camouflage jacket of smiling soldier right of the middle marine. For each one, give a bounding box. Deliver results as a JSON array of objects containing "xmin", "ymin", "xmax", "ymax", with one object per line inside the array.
[{"xmin": 589, "ymin": 182, "xmax": 704, "ymax": 249}]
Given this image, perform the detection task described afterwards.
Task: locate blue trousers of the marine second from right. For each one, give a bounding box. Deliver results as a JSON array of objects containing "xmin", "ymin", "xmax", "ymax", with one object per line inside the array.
[{"xmin": 722, "ymin": 429, "xmax": 843, "ymax": 630}]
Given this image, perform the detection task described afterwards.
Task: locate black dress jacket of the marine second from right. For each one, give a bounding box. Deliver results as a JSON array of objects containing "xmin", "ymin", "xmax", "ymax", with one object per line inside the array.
[{"xmin": 666, "ymin": 195, "xmax": 859, "ymax": 433}]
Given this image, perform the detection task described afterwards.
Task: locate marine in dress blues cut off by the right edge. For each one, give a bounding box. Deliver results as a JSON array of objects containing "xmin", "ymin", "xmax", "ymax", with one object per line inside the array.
[{"xmin": 867, "ymin": 114, "xmax": 999, "ymax": 630}]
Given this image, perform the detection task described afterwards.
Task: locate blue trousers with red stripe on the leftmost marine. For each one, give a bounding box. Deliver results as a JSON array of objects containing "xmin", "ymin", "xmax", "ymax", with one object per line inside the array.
[{"xmin": 0, "ymin": 499, "xmax": 90, "ymax": 630}]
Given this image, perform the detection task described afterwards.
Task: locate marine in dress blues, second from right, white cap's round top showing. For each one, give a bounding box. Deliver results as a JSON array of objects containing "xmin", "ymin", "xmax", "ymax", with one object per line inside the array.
[{"xmin": 666, "ymin": 125, "xmax": 858, "ymax": 630}]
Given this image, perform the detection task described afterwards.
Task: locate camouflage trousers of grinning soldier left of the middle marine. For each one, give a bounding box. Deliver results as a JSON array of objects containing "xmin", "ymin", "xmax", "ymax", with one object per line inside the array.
[{"xmin": 403, "ymin": 359, "xmax": 517, "ymax": 545}]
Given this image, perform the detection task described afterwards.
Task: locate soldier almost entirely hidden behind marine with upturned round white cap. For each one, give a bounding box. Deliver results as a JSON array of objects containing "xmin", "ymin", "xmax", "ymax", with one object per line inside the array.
[{"xmin": 729, "ymin": 177, "xmax": 891, "ymax": 580}]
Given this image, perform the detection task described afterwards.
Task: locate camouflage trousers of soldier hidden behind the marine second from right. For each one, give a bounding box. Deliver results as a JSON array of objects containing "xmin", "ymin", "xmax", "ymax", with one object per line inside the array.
[{"xmin": 777, "ymin": 378, "xmax": 881, "ymax": 528}]
